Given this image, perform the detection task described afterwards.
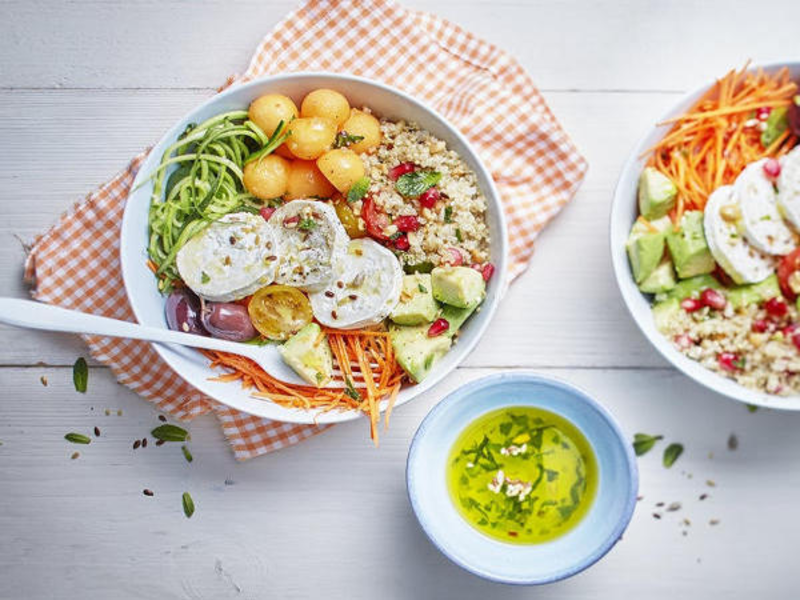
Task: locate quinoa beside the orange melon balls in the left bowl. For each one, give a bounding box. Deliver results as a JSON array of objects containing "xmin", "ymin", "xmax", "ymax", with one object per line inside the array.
[{"xmin": 360, "ymin": 119, "xmax": 489, "ymax": 266}]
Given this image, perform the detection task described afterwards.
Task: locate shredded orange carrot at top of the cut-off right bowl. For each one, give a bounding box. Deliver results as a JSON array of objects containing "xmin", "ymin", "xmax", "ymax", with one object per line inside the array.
[{"xmin": 643, "ymin": 65, "xmax": 798, "ymax": 211}]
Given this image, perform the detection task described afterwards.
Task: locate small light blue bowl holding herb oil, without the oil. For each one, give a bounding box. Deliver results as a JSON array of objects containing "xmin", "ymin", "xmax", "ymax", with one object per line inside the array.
[{"xmin": 406, "ymin": 373, "xmax": 639, "ymax": 585}]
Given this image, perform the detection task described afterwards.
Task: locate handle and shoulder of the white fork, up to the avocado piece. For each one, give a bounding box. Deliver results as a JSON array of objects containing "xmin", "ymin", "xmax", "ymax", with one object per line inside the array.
[{"xmin": 0, "ymin": 298, "xmax": 308, "ymax": 385}]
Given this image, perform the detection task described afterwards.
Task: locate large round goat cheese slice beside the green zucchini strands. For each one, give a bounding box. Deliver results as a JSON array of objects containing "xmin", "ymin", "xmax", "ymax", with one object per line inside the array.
[{"xmin": 176, "ymin": 212, "xmax": 278, "ymax": 302}]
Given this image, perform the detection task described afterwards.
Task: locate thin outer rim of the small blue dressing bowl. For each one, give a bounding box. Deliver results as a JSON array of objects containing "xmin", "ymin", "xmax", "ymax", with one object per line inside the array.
[{"xmin": 406, "ymin": 370, "xmax": 639, "ymax": 586}]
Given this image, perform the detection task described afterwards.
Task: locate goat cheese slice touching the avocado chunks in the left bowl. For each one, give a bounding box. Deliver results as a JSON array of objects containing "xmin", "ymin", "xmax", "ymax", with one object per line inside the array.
[{"xmin": 309, "ymin": 238, "xmax": 403, "ymax": 329}]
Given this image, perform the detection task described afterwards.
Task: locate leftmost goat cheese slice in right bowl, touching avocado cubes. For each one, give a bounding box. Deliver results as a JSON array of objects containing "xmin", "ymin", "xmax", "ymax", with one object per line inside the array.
[{"xmin": 703, "ymin": 185, "xmax": 775, "ymax": 284}]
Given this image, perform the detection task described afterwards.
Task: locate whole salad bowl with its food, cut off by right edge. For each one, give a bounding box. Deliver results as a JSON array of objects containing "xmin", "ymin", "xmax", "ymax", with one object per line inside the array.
[{"xmin": 611, "ymin": 63, "xmax": 800, "ymax": 410}]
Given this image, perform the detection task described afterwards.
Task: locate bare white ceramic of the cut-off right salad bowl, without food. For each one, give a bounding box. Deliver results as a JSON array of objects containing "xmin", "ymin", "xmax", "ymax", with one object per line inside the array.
[{"xmin": 610, "ymin": 62, "xmax": 800, "ymax": 410}]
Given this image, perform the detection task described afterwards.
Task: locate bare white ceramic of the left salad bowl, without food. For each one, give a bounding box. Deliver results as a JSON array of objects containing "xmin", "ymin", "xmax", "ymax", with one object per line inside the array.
[{"xmin": 120, "ymin": 73, "xmax": 508, "ymax": 423}]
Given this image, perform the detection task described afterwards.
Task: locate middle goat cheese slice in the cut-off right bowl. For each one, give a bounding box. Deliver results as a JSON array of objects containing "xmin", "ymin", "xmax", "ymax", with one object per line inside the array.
[{"xmin": 733, "ymin": 159, "xmax": 795, "ymax": 255}]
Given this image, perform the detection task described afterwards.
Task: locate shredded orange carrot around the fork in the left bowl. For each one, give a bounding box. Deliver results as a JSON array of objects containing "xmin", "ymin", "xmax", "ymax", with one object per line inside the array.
[{"xmin": 202, "ymin": 329, "xmax": 406, "ymax": 446}]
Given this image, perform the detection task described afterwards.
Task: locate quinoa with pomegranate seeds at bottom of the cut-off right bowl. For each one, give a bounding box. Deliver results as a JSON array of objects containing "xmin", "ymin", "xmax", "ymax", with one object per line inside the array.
[{"xmin": 661, "ymin": 303, "xmax": 800, "ymax": 396}]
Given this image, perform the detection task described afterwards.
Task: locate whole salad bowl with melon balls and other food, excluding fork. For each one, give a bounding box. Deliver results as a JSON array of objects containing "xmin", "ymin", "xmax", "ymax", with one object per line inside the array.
[{"xmin": 121, "ymin": 73, "xmax": 507, "ymax": 437}]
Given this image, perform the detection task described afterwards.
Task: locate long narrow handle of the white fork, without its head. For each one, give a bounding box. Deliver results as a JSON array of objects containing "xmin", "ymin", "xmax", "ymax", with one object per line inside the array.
[{"xmin": 0, "ymin": 298, "xmax": 252, "ymax": 355}]
